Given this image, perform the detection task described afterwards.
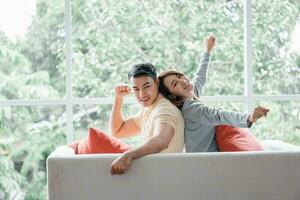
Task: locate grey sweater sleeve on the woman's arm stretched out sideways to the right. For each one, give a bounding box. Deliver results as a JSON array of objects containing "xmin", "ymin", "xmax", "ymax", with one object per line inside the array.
[{"xmin": 182, "ymin": 101, "xmax": 249, "ymax": 128}]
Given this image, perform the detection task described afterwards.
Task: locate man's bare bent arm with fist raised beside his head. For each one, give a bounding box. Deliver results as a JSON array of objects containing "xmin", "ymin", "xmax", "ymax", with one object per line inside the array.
[{"xmin": 110, "ymin": 85, "xmax": 140, "ymax": 138}]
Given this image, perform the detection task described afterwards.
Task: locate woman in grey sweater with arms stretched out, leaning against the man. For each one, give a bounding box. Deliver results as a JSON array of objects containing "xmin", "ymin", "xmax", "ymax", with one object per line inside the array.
[{"xmin": 159, "ymin": 35, "xmax": 269, "ymax": 152}]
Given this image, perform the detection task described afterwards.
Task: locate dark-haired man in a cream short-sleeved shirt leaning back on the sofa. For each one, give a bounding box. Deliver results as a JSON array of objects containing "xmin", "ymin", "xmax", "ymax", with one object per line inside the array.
[{"xmin": 110, "ymin": 64, "xmax": 184, "ymax": 174}]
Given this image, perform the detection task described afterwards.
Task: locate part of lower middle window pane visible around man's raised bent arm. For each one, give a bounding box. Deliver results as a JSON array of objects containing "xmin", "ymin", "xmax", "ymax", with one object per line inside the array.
[{"xmin": 73, "ymin": 104, "xmax": 143, "ymax": 146}]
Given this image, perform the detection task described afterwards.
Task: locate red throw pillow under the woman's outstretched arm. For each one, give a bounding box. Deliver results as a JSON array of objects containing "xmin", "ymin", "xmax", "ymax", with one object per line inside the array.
[{"xmin": 216, "ymin": 125, "xmax": 263, "ymax": 151}]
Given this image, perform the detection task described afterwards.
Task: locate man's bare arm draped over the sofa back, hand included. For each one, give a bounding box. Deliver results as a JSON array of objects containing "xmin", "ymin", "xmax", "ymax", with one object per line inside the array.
[{"xmin": 111, "ymin": 123, "xmax": 175, "ymax": 174}]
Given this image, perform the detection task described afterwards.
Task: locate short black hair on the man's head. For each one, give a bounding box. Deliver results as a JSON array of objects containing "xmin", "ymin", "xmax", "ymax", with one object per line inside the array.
[{"xmin": 128, "ymin": 63, "xmax": 157, "ymax": 80}]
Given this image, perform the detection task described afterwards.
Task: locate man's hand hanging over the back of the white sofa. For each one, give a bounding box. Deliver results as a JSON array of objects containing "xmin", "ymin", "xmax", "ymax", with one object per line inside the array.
[{"xmin": 111, "ymin": 152, "xmax": 133, "ymax": 175}]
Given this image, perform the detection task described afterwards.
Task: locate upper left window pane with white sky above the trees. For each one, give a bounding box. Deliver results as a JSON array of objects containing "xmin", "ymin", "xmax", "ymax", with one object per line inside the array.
[{"xmin": 0, "ymin": 0, "xmax": 65, "ymax": 100}]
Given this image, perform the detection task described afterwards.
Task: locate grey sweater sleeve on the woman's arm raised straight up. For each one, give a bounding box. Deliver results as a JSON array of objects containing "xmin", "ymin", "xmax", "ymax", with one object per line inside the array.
[{"xmin": 193, "ymin": 52, "xmax": 210, "ymax": 96}]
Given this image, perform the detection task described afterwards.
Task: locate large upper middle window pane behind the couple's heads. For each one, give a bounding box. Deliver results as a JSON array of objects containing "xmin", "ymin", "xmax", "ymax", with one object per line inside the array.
[{"xmin": 72, "ymin": 0, "xmax": 243, "ymax": 97}]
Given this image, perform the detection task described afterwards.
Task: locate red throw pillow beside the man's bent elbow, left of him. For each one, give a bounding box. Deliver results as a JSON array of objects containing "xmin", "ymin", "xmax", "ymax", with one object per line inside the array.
[{"xmin": 68, "ymin": 128, "xmax": 131, "ymax": 154}]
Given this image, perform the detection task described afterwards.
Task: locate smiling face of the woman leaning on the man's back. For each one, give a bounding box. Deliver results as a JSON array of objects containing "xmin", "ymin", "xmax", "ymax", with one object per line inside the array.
[{"xmin": 163, "ymin": 74, "xmax": 194, "ymax": 97}]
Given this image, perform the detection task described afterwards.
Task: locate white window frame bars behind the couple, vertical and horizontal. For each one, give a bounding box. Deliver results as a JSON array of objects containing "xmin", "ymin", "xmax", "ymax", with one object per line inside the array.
[{"xmin": 0, "ymin": 0, "xmax": 300, "ymax": 143}]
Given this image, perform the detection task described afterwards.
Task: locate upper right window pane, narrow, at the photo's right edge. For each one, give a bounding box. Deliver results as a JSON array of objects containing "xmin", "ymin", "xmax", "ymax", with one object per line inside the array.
[{"xmin": 252, "ymin": 0, "xmax": 300, "ymax": 94}]
